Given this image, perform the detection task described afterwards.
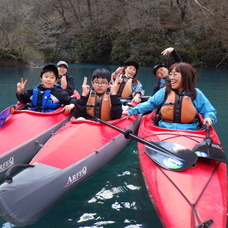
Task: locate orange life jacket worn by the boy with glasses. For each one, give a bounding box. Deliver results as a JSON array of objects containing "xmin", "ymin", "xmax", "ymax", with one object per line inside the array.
[{"xmin": 86, "ymin": 90, "xmax": 111, "ymax": 121}]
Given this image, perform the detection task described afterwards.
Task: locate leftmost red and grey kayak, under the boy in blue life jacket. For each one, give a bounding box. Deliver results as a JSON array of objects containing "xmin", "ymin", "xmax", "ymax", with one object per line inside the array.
[{"xmin": 0, "ymin": 106, "xmax": 71, "ymax": 182}]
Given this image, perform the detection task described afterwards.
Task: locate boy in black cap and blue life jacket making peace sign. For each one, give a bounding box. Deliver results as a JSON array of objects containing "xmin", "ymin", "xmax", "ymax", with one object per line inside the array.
[{"xmin": 16, "ymin": 64, "xmax": 76, "ymax": 113}]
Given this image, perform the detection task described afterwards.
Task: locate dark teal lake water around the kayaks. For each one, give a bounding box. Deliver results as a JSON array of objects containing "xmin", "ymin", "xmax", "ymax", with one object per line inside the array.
[{"xmin": 0, "ymin": 65, "xmax": 228, "ymax": 228}]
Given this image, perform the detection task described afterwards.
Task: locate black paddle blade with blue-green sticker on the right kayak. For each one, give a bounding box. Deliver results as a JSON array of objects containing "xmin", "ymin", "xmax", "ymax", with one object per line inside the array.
[{"xmin": 146, "ymin": 141, "xmax": 198, "ymax": 171}]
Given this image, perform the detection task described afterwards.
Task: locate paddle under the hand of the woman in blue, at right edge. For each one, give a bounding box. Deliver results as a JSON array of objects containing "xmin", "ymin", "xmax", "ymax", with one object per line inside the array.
[{"xmin": 193, "ymin": 124, "xmax": 227, "ymax": 163}]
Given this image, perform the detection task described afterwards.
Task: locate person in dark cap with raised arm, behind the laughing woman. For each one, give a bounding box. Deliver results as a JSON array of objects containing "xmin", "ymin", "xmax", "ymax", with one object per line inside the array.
[{"xmin": 153, "ymin": 47, "xmax": 182, "ymax": 94}]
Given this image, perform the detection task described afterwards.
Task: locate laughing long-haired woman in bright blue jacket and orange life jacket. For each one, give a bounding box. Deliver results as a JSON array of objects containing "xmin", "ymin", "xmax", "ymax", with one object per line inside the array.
[{"xmin": 125, "ymin": 62, "xmax": 217, "ymax": 130}]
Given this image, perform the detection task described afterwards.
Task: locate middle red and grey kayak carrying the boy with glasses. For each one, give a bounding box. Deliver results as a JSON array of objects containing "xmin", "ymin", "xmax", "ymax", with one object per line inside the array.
[{"xmin": 0, "ymin": 117, "xmax": 141, "ymax": 226}]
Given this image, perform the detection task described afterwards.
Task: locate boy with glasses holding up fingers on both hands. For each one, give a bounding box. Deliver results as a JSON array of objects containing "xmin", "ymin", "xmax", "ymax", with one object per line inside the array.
[{"xmin": 73, "ymin": 68, "xmax": 122, "ymax": 121}]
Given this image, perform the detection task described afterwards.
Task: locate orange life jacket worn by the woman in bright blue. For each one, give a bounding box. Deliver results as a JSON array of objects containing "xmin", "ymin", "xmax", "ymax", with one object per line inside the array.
[{"xmin": 160, "ymin": 91, "xmax": 197, "ymax": 123}]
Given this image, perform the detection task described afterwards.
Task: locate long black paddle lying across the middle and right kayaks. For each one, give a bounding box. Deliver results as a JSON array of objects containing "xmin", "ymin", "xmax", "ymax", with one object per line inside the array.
[{"xmin": 88, "ymin": 115, "xmax": 198, "ymax": 171}]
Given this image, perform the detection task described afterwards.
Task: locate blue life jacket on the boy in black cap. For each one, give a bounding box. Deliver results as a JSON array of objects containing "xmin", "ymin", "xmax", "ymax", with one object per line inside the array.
[{"xmin": 30, "ymin": 88, "xmax": 60, "ymax": 112}]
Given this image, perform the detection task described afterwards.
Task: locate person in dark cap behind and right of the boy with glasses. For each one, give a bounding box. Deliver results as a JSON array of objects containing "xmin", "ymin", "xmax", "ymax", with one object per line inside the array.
[{"xmin": 112, "ymin": 61, "xmax": 144, "ymax": 103}]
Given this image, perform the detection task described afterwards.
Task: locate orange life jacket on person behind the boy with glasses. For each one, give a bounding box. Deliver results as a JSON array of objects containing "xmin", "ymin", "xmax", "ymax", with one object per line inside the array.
[{"xmin": 117, "ymin": 75, "xmax": 133, "ymax": 97}]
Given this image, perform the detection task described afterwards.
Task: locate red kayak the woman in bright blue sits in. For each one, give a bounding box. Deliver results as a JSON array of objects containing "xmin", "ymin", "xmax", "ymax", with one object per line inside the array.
[{"xmin": 138, "ymin": 114, "xmax": 227, "ymax": 228}]
